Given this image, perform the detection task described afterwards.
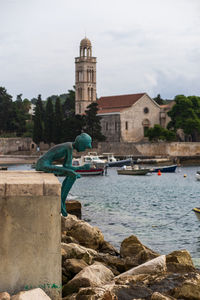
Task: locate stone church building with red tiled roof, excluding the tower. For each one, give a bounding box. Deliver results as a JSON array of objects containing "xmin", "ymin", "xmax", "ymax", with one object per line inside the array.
[{"xmin": 98, "ymin": 93, "xmax": 160, "ymax": 142}]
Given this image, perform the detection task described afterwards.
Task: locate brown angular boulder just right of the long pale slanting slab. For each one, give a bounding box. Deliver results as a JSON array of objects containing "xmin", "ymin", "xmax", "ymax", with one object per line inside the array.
[{"xmin": 166, "ymin": 250, "xmax": 195, "ymax": 272}]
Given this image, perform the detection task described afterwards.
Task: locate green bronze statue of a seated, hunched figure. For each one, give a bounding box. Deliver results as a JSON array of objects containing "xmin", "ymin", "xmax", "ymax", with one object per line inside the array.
[{"xmin": 36, "ymin": 133, "xmax": 92, "ymax": 217}]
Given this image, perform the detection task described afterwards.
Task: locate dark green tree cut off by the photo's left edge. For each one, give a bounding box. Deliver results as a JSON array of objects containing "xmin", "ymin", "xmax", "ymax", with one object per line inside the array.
[{"xmin": 0, "ymin": 87, "xmax": 13, "ymax": 133}]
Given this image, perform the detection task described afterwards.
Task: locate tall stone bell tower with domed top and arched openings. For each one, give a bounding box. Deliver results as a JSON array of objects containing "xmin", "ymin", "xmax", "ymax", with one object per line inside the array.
[{"xmin": 75, "ymin": 37, "xmax": 96, "ymax": 115}]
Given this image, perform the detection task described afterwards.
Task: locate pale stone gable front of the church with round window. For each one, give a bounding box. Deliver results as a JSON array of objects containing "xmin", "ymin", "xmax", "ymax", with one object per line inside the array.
[{"xmin": 120, "ymin": 95, "xmax": 160, "ymax": 142}]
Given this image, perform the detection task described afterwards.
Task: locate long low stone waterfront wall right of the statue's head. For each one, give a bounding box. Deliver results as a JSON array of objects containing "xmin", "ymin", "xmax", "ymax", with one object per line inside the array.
[{"xmin": 97, "ymin": 142, "xmax": 200, "ymax": 156}]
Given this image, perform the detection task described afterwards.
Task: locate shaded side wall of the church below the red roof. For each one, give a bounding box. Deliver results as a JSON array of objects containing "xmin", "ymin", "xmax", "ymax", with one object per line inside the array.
[{"xmin": 101, "ymin": 114, "xmax": 121, "ymax": 142}]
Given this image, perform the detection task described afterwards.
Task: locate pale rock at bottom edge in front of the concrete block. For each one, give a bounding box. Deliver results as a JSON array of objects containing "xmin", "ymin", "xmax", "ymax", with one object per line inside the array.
[{"xmin": 11, "ymin": 288, "xmax": 51, "ymax": 300}]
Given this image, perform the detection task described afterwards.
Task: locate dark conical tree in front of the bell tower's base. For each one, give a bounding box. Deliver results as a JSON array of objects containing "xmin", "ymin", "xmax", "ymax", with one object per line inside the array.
[{"xmin": 85, "ymin": 102, "xmax": 106, "ymax": 141}]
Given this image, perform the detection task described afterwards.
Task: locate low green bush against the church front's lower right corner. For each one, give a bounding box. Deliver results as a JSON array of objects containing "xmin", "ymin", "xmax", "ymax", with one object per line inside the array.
[{"xmin": 145, "ymin": 124, "xmax": 176, "ymax": 142}]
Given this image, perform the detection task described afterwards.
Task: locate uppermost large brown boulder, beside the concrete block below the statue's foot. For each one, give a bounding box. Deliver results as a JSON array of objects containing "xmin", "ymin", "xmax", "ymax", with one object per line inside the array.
[{"xmin": 62, "ymin": 215, "xmax": 104, "ymax": 250}]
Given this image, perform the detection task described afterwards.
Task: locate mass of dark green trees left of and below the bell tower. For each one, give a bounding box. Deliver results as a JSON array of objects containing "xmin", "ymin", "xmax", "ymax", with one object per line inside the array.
[{"xmin": 0, "ymin": 87, "xmax": 105, "ymax": 145}]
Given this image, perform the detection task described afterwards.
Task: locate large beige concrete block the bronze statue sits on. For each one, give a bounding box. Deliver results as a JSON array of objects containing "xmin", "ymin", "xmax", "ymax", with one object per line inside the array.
[{"xmin": 0, "ymin": 171, "xmax": 61, "ymax": 300}]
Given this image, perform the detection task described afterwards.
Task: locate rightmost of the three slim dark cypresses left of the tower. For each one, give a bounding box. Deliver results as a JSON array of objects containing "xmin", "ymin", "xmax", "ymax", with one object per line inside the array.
[{"xmin": 53, "ymin": 97, "xmax": 63, "ymax": 144}]
